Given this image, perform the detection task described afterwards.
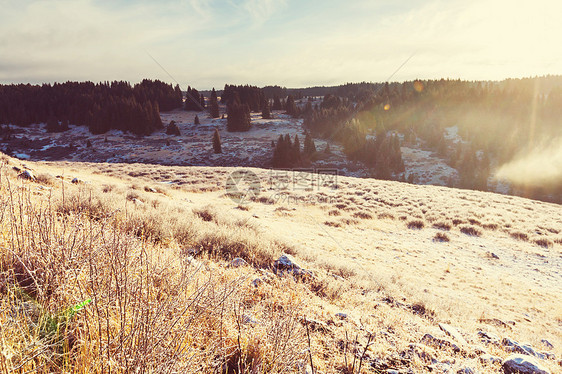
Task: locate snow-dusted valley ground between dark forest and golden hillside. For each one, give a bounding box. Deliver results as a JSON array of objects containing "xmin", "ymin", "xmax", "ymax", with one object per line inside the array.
[{"xmin": 3, "ymin": 108, "xmax": 509, "ymax": 193}]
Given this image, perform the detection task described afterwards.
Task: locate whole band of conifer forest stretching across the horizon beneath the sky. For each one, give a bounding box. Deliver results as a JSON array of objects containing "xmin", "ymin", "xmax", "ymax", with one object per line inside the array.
[{"xmin": 0, "ymin": 76, "xmax": 562, "ymax": 202}]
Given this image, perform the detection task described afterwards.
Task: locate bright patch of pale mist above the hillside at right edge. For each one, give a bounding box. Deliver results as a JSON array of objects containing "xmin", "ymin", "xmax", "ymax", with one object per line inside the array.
[{"xmin": 496, "ymin": 137, "xmax": 562, "ymax": 187}]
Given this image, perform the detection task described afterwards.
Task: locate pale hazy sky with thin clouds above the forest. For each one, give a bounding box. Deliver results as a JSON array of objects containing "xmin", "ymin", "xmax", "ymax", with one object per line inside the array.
[{"xmin": 0, "ymin": 0, "xmax": 562, "ymax": 89}]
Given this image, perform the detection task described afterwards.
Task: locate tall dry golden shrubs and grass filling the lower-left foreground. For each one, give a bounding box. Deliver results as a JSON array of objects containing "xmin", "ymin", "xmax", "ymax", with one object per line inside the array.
[{"xmin": 0, "ymin": 167, "xmax": 306, "ymax": 373}]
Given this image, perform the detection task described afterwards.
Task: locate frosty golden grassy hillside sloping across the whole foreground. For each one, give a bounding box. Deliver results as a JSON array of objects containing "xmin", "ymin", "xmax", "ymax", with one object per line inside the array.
[{"xmin": 0, "ymin": 153, "xmax": 562, "ymax": 373}]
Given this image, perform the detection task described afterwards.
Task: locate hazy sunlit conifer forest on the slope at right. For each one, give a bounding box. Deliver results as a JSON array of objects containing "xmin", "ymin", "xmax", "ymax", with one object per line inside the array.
[{"xmin": 301, "ymin": 76, "xmax": 562, "ymax": 202}]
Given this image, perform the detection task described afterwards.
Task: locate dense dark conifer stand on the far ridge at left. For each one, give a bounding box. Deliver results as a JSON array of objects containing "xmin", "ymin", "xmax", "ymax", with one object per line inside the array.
[{"xmin": 0, "ymin": 79, "xmax": 183, "ymax": 135}]
